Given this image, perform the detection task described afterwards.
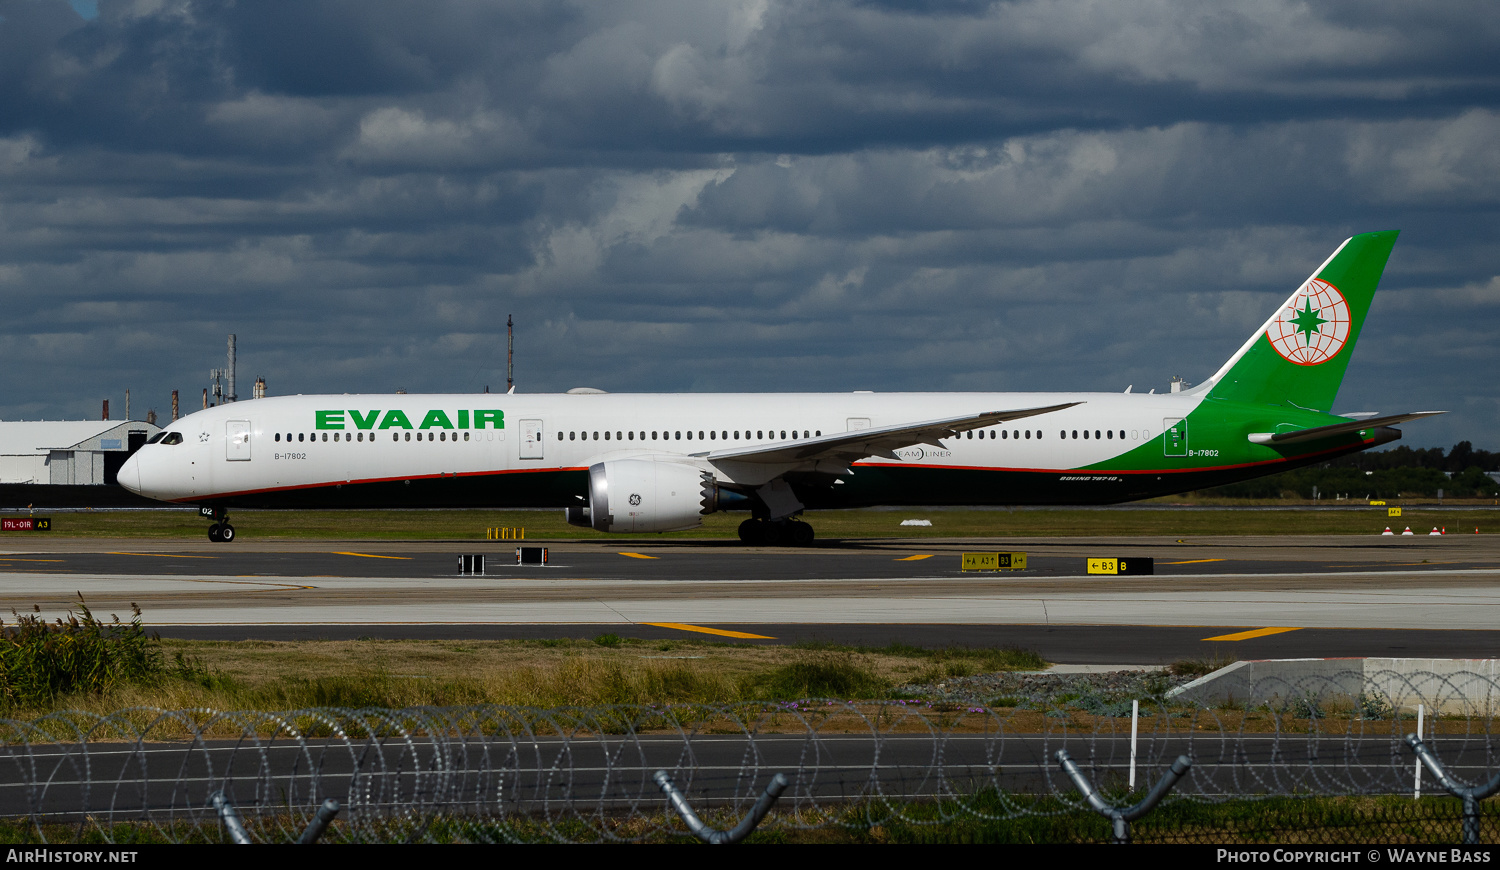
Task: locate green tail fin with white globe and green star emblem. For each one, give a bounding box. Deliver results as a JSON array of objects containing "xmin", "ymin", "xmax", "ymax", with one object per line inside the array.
[{"xmin": 1194, "ymin": 231, "xmax": 1397, "ymax": 411}]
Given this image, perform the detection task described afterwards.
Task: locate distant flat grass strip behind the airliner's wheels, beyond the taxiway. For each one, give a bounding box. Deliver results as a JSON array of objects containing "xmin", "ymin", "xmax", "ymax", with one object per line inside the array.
[{"xmin": 6, "ymin": 503, "xmax": 1500, "ymax": 542}]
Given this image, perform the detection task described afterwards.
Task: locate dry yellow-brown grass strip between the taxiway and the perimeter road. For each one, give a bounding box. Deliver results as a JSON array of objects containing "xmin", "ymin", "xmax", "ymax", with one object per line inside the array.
[{"xmin": 5, "ymin": 635, "xmax": 1046, "ymax": 719}]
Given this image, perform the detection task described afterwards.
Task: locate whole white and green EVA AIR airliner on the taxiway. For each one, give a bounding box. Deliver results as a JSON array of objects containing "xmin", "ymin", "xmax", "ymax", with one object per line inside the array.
[{"xmin": 119, "ymin": 233, "xmax": 1440, "ymax": 545}]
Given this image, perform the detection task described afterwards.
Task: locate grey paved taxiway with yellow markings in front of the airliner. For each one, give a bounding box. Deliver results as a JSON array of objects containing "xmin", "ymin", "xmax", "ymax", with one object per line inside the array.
[{"xmin": 0, "ymin": 536, "xmax": 1500, "ymax": 665}]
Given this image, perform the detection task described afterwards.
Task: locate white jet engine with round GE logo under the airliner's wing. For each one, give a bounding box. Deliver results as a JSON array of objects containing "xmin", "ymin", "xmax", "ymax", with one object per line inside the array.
[{"xmin": 566, "ymin": 459, "xmax": 749, "ymax": 533}]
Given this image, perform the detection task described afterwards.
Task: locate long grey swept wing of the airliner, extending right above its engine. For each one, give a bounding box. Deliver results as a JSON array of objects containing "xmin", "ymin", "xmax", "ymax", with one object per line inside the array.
[{"xmin": 693, "ymin": 402, "xmax": 1083, "ymax": 464}]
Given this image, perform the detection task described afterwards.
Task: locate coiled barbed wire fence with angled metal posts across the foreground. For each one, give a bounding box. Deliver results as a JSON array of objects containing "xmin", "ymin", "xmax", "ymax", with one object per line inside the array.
[{"xmin": 0, "ymin": 672, "xmax": 1500, "ymax": 843}]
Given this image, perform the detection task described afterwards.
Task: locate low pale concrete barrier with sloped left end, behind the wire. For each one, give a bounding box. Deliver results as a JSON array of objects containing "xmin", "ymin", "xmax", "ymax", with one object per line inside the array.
[{"xmin": 1167, "ymin": 659, "xmax": 1500, "ymax": 716}]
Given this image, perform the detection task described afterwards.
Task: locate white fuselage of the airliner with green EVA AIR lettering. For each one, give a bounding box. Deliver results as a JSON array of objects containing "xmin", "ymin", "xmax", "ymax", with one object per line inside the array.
[{"xmin": 120, "ymin": 393, "xmax": 1200, "ymax": 507}]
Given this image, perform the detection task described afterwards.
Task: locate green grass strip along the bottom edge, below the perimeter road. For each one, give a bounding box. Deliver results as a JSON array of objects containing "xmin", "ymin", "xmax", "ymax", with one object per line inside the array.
[{"xmin": 0, "ymin": 789, "xmax": 1500, "ymax": 840}]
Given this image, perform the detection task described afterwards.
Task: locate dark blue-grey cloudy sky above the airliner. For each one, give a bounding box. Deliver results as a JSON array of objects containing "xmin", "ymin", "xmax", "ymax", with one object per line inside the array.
[{"xmin": 0, "ymin": 0, "xmax": 1500, "ymax": 449}]
